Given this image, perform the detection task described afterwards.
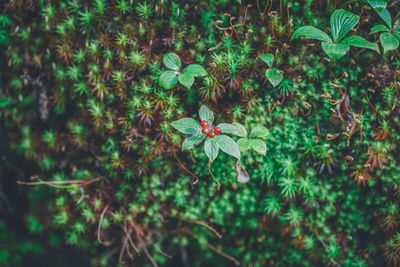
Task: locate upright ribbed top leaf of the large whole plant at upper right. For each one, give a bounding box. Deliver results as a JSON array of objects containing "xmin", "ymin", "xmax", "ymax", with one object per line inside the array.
[{"xmin": 331, "ymin": 9, "xmax": 360, "ymax": 41}]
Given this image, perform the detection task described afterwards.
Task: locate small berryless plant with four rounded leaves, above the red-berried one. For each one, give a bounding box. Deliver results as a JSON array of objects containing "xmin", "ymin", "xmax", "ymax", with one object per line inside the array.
[{"xmin": 160, "ymin": 53, "xmax": 207, "ymax": 89}]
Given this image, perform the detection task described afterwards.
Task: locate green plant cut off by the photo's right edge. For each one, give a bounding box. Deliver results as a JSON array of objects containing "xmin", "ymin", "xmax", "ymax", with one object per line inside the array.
[{"xmin": 368, "ymin": 0, "xmax": 400, "ymax": 53}]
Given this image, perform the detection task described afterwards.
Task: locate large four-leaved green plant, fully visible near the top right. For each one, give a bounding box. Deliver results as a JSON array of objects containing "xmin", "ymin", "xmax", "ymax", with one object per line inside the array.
[{"xmin": 292, "ymin": 9, "xmax": 379, "ymax": 59}]
